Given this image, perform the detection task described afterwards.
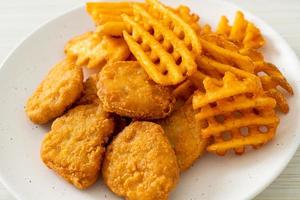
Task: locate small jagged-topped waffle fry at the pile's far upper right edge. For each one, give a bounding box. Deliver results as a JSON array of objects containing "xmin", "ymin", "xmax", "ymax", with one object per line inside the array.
[{"xmin": 217, "ymin": 11, "xmax": 265, "ymax": 49}]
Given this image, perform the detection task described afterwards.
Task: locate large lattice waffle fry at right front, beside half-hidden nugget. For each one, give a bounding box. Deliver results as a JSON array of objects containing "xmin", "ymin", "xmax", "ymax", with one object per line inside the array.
[{"xmin": 193, "ymin": 72, "xmax": 279, "ymax": 155}]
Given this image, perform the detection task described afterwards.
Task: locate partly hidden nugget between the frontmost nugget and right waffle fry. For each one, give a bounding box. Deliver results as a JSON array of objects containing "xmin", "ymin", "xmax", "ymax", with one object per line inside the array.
[{"xmin": 159, "ymin": 104, "xmax": 208, "ymax": 171}]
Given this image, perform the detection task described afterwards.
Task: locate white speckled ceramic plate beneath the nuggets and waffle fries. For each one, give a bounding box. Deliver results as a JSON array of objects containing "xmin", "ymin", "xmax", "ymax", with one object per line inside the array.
[{"xmin": 0, "ymin": 0, "xmax": 300, "ymax": 200}]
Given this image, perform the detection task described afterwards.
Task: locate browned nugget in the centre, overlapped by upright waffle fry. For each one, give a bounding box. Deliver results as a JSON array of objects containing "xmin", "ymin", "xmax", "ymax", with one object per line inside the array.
[{"xmin": 97, "ymin": 61, "xmax": 175, "ymax": 119}]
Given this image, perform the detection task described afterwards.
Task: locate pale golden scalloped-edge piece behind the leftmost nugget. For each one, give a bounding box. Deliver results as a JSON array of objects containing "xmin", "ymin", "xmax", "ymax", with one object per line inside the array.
[{"xmin": 65, "ymin": 32, "xmax": 130, "ymax": 69}]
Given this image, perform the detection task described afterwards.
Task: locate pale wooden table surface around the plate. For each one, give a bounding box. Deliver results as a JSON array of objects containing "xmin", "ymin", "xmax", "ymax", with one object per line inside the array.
[{"xmin": 0, "ymin": 0, "xmax": 300, "ymax": 200}]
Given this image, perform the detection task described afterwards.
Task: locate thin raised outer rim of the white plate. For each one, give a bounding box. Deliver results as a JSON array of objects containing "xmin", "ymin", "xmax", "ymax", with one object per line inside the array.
[{"xmin": 0, "ymin": 0, "xmax": 300, "ymax": 200}]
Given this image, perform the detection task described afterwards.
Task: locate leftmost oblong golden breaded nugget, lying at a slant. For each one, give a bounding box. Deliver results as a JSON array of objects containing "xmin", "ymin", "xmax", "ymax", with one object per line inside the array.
[{"xmin": 25, "ymin": 58, "xmax": 83, "ymax": 124}]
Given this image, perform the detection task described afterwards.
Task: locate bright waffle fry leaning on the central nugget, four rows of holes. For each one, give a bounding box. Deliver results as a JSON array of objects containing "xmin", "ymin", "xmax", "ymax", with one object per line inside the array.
[{"xmin": 123, "ymin": 0, "xmax": 201, "ymax": 85}]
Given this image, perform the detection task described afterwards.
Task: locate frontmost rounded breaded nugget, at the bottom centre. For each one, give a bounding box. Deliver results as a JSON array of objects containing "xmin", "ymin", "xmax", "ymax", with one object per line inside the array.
[{"xmin": 102, "ymin": 121, "xmax": 179, "ymax": 200}]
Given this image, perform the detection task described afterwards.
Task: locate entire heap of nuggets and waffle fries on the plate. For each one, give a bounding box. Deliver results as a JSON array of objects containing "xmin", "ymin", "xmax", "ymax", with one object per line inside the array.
[{"xmin": 26, "ymin": 0, "xmax": 293, "ymax": 200}]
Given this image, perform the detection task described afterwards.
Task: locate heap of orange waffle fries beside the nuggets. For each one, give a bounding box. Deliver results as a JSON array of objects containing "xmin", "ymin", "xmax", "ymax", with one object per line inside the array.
[{"xmin": 87, "ymin": 0, "xmax": 293, "ymax": 155}]
